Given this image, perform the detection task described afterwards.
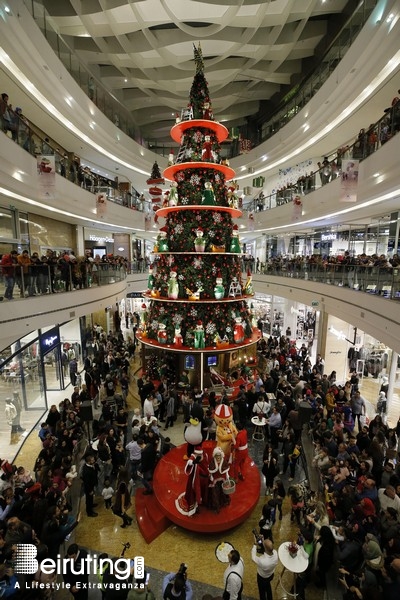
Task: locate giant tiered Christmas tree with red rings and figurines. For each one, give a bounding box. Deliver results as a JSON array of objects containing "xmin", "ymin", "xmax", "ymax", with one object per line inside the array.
[{"xmin": 138, "ymin": 45, "xmax": 259, "ymax": 389}]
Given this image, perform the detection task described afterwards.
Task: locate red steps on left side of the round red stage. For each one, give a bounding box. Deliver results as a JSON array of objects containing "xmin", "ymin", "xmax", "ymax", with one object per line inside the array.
[{"xmin": 135, "ymin": 488, "xmax": 171, "ymax": 544}]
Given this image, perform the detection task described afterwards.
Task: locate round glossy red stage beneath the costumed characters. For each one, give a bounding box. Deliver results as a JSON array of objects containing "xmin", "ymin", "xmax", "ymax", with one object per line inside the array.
[{"xmin": 153, "ymin": 441, "xmax": 261, "ymax": 533}]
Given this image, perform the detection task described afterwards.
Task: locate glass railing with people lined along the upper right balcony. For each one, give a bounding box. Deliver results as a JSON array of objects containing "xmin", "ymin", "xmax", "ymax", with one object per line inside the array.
[{"xmin": 244, "ymin": 101, "xmax": 400, "ymax": 212}]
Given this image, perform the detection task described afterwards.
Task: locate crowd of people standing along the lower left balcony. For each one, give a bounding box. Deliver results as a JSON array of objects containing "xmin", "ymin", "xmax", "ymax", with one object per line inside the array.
[{"xmin": 0, "ymin": 249, "xmax": 130, "ymax": 300}]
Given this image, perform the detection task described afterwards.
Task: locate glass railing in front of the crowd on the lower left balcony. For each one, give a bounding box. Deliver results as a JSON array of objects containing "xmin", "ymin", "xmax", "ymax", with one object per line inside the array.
[{"xmin": 0, "ymin": 261, "xmax": 128, "ymax": 300}]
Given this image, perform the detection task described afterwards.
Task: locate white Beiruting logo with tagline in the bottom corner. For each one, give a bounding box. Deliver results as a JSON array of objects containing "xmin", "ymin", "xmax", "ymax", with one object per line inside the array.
[{"xmin": 13, "ymin": 544, "xmax": 145, "ymax": 589}]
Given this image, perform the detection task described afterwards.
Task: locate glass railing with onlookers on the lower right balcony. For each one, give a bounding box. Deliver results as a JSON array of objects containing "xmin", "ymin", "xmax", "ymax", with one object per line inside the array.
[{"xmin": 260, "ymin": 261, "xmax": 400, "ymax": 300}]
